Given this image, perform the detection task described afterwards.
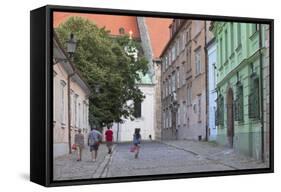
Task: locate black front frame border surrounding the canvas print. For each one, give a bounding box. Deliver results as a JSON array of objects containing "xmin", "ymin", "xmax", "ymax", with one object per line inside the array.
[{"xmin": 30, "ymin": 5, "xmax": 274, "ymax": 187}]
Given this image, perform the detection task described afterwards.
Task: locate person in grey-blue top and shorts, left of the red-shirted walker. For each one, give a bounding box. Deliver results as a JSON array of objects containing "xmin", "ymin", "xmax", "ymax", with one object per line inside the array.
[{"xmin": 88, "ymin": 127, "xmax": 102, "ymax": 162}]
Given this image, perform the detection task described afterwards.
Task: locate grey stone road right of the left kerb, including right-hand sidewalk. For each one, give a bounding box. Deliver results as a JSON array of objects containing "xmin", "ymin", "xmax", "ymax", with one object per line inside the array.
[{"xmin": 106, "ymin": 141, "xmax": 265, "ymax": 177}]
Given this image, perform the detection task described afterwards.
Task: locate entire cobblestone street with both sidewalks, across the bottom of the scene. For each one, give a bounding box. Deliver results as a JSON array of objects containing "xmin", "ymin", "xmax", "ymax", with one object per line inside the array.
[{"xmin": 54, "ymin": 141, "xmax": 265, "ymax": 180}]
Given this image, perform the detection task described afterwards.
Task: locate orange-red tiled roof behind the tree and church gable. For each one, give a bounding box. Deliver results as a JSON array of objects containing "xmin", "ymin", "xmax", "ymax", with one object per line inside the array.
[{"xmin": 53, "ymin": 12, "xmax": 172, "ymax": 58}]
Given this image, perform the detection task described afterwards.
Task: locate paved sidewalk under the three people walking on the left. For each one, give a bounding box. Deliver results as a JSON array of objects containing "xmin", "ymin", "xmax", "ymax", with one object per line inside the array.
[{"xmin": 54, "ymin": 144, "xmax": 115, "ymax": 180}]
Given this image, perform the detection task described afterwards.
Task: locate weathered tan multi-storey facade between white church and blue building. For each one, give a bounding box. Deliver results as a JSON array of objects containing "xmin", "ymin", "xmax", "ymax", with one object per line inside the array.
[{"xmin": 161, "ymin": 19, "xmax": 208, "ymax": 140}]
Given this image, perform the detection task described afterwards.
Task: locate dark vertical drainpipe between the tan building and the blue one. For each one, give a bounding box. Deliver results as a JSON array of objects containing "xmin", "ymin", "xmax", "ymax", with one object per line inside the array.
[{"xmin": 204, "ymin": 21, "xmax": 209, "ymax": 141}]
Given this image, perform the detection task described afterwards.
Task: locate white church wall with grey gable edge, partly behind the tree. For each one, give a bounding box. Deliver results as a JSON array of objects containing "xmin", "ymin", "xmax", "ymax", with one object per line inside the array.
[{"xmin": 113, "ymin": 24, "xmax": 156, "ymax": 142}]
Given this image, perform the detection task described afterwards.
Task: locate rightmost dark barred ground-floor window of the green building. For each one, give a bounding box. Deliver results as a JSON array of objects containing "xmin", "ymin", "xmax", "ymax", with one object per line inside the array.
[{"xmin": 248, "ymin": 73, "xmax": 260, "ymax": 119}]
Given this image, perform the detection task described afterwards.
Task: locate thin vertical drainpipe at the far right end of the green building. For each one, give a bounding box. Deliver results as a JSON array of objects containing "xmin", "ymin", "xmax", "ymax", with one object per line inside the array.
[{"xmin": 258, "ymin": 24, "xmax": 265, "ymax": 162}]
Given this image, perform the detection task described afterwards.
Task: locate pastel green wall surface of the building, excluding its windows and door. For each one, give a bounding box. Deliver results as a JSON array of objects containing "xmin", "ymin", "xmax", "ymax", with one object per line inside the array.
[{"xmin": 212, "ymin": 22, "xmax": 265, "ymax": 159}]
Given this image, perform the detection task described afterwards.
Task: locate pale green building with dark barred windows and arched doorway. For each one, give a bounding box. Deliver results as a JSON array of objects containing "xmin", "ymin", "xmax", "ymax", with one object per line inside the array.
[{"xmin": 211, "ymin": 22, "xmax": 268, "ymax": 160}]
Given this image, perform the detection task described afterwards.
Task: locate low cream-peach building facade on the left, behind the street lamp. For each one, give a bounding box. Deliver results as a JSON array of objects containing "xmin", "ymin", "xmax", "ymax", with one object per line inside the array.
[{"xmin": 53, "ymin": 35, "xmax": 90, "ymax": 158}]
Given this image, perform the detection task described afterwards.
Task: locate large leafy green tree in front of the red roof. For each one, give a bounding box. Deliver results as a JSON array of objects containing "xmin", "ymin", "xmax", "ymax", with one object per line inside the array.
[{"xmin": 56, "ymin": 17, "xmax": 148, "ymax": 126}]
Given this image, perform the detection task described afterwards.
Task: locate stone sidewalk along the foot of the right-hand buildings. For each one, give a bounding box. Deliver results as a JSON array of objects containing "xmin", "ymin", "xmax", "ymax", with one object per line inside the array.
[{"xmin": 161, "ymin": 140, "xmax": 266, "ymax": 169}]
